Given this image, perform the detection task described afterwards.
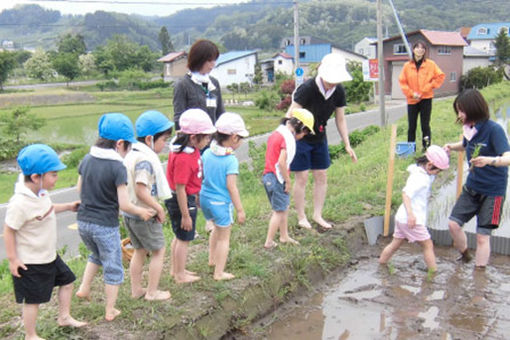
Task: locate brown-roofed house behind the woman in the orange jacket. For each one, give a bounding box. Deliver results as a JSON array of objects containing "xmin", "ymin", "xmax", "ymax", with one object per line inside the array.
[{"xmin": 383, "ymin": 30, "xmax": 467, "ymax": 99}]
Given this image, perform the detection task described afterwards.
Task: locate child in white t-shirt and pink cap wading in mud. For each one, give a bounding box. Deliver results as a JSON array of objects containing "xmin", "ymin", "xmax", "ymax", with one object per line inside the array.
[{"xmin": 379, "ymin": 145, "xmax": 449, "ymax": 273}]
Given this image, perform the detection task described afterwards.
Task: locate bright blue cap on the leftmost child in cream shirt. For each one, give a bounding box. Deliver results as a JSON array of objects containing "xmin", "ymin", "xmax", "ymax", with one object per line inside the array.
[{"xmin": 17, "ymin": 144, "xmax": 67, "ymax": 175}]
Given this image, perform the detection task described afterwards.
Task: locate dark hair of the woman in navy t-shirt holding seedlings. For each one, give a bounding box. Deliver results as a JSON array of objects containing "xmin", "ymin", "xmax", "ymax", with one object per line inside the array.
[{"xmin": 453, "ymin": 89, "xmax": 490, "ymax": 123}]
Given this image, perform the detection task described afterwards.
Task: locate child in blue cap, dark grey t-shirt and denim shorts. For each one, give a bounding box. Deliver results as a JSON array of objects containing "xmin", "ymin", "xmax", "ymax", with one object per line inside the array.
[{"xmin": 76, "ymin": 113, "xmax": 155, "ymax": 321}]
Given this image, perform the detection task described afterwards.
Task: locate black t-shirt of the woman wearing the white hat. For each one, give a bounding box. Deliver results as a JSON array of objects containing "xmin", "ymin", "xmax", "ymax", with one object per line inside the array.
[{"xmin": 292, "ymin": 78, "xmax": 347, "ymax": 143}]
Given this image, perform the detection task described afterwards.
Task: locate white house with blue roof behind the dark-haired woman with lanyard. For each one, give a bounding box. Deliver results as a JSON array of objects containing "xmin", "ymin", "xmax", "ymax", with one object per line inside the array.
[{"xmin": 211, "ymin": 51, "xmax": 257, "ymax": 87}]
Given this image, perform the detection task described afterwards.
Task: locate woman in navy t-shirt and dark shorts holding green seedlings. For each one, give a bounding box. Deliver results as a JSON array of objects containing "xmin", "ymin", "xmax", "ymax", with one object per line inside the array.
[{"xmin": 445, "ymin": 89, "xmax": 510, "ymax": 269}]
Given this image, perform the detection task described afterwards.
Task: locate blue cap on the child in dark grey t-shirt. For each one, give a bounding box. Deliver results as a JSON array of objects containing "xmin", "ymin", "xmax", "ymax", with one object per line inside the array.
[{"xmin": 97, "ymin": 113, "xmax": 136, "ymax": 143}]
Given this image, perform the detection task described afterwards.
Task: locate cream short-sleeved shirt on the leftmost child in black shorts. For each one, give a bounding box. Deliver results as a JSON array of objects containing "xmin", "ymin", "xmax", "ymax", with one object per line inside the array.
[{"xmin": 5, "ymin": 182, "xmax": 57, "ymax": 264}]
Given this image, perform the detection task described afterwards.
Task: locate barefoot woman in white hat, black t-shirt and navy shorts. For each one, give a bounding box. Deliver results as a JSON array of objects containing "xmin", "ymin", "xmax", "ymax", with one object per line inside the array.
[{"xmin": 287, "ymin": 53, "xmax": 357, "ymax": 229}]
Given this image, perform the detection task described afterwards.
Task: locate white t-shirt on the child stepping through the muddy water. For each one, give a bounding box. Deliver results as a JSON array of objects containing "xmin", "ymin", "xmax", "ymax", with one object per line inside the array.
[{"xmin": 395, "ymin": 164, "xmax": 435, "ymax": 226}]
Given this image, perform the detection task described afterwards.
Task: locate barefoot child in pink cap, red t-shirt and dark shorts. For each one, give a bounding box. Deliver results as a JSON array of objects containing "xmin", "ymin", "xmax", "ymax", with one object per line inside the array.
[{"xmin": 165, "ymin": 109, "xmax": 216, "ymax": 283}]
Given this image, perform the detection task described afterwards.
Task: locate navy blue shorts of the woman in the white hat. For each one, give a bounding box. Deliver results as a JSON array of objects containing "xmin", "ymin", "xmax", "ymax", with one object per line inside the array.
[{"xmin": 290, "ymin": 138, "xmax": 331, "ymax": 171}]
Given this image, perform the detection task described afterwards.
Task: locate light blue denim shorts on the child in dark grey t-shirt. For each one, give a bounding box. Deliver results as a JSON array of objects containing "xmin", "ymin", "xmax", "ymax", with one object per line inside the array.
[{"xmin": 78, "ymin": 221, "xmax": 124, "ymax": 285}]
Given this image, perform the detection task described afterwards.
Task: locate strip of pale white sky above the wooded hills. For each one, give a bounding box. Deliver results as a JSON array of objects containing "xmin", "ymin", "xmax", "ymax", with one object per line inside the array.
[{"xmin": 0, "ymin": 0, "xmax": 247, "ymax": 16}]
